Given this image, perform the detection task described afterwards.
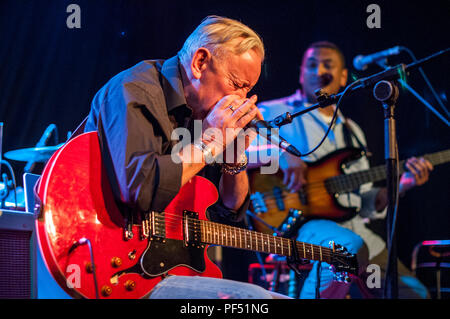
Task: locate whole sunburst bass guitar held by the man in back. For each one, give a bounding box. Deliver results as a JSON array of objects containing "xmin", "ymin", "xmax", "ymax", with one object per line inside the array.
[{"xmin": 249, "ymin": 148, "xmax": 450, "ymax": 233}]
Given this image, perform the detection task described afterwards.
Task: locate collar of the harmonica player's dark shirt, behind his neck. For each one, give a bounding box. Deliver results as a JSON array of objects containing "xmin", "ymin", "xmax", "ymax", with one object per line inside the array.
[{"xmin": 161, "ymin": 55, "xmax": 190, "ymax": 111}]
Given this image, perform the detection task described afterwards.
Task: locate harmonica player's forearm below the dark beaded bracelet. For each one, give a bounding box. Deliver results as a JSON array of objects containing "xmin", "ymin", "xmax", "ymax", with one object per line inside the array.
[{"xmin": 219, "ymin": 171, "xmax": 249, "ymax": 210}]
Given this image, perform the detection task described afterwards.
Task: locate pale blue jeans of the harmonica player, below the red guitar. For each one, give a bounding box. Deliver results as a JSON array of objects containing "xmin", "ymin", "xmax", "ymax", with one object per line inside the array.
[{"xmin": 149, "ymin": 276, "xmax": 287, "ymax": 299}]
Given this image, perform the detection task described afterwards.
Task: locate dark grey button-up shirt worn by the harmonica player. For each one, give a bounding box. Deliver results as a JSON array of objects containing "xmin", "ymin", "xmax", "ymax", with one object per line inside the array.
[{"xmin": 85, "ymin": 56, "xmax": 249, "ymax": 222}]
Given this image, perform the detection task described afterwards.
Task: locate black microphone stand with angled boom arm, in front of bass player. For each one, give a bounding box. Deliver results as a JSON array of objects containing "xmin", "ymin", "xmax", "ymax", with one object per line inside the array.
[{"xmin": 269, "ymin": 48, "xmax": 450, "ymax": 299}]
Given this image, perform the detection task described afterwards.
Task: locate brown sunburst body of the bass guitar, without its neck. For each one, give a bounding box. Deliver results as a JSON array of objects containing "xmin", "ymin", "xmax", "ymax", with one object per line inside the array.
[{"xmin": 249, "ymin": 148, "xmax": 361, "ymax": 233}]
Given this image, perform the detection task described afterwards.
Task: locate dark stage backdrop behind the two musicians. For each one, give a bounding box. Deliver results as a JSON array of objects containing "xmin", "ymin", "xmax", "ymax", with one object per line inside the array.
[{"xmin": 0, "ymin": 0, "xmax": 450, "ymax": 288}]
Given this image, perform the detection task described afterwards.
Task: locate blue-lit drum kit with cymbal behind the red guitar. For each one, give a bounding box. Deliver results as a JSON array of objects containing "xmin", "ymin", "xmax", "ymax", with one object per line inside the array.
[{"xmin": 0, "ymin": 124, "xmax": 64, "ymax": 210}]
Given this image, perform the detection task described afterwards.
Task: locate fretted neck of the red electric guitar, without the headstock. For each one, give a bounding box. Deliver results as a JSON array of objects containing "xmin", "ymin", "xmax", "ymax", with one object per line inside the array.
[{"xmin": 196, "ymin": 220, "xmax": 333, "ymax": 263}]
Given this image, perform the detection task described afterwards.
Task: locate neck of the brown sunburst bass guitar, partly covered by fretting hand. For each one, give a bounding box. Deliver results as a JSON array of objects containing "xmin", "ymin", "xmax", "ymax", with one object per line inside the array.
[{"xmin": 325, "ymin": 149, "xmax": 450, "ymax": 194}]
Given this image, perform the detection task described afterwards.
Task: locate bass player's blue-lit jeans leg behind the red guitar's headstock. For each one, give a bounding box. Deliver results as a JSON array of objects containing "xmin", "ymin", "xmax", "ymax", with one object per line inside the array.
[{"xmin": 297, "ymin": 219, "xmax": 364, "ymax": 299}]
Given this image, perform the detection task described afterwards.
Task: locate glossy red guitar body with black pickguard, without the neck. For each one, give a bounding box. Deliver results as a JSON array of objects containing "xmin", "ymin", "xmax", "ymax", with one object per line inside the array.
[{"xmin": 36, "ymin": 132, "xmax": 222, "ymax": 299}]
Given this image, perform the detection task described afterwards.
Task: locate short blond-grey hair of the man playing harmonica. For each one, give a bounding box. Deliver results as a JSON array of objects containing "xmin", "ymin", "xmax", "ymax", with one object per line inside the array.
[{"xmin": 178, "ymin": 15, "xmax": 264, "ymax": 65}]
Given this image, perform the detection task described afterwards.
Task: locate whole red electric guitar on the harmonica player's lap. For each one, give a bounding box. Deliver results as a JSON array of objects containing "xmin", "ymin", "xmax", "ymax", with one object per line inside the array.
[{"xmin": 36, "ymin": 132, "xmax": 358, "ymax": 298}]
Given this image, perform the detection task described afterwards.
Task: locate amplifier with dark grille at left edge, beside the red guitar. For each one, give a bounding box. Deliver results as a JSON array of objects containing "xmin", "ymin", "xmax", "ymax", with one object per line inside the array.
[{"xmin": 0, "ymin": 173, "xmax": 71, "ymax": 299}]
